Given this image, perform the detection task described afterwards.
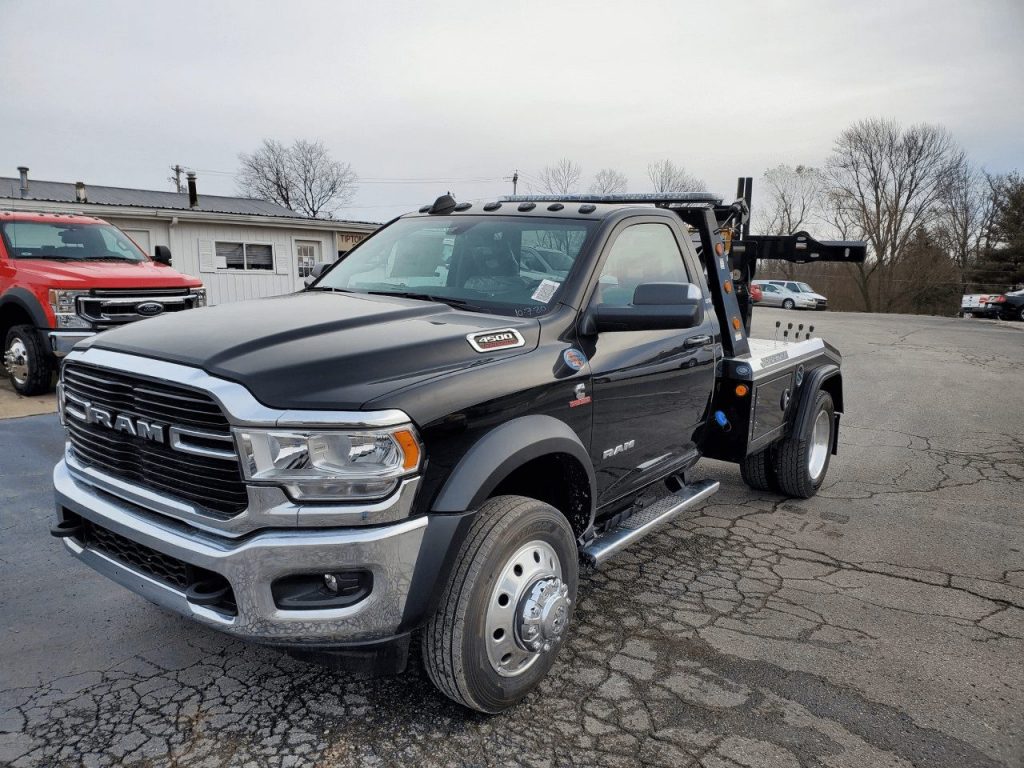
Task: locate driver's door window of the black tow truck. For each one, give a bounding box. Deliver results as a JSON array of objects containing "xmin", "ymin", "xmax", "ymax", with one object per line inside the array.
[{"xmin": 594, "ymin": 224, "xmax": 690, "ymax": 306}]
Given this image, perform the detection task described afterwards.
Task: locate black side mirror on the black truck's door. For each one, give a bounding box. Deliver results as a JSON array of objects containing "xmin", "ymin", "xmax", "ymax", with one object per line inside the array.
[{"xmin": 582, "ymin": 283, "xmax": 705, "ymax": 333}]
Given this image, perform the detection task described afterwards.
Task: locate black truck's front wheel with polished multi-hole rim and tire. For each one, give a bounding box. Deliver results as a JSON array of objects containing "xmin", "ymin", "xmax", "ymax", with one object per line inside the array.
[{"xmin": 423, "ymin": 496, "xmax": 579, "ymax": 714}]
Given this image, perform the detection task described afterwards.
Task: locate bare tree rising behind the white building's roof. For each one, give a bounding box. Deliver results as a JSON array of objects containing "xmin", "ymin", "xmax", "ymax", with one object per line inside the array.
[{"xmin": 236, "ymin": 138, "xmax": 357, "ymax": 218}]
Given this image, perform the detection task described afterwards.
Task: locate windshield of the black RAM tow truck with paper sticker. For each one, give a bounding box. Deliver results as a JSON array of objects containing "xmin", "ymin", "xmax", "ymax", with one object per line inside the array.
[{"xmin": 313, "ymin": 216, "xmax": 596, "ymax": 317}]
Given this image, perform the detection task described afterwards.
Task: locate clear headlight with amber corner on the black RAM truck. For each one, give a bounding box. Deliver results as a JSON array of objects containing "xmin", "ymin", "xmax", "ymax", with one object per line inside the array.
[{"xmin": 234, "ymin": 427, "xmax": 422, "ymax": 501}]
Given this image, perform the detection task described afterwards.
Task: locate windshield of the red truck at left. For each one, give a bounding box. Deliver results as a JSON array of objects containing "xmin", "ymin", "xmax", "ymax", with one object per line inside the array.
[{"xmin": 0, "ymin": 221, "xmax": 145, "ymax": 261}]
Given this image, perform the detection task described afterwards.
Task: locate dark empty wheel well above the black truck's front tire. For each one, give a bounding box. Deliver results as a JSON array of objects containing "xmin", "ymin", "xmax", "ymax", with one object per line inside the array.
[{"xmin": 492, "ymin": 454, "xmax": 593, "ymax": 538}]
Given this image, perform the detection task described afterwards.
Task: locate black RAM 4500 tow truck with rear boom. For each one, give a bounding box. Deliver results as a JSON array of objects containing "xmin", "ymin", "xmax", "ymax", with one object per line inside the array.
[{"xmin": 52, "ymin": 179, "xmax": 864, "ymax": 713}]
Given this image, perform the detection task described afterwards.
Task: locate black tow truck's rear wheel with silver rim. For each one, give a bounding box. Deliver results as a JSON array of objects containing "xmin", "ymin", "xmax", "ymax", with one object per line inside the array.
[{"xmin": 773, "ymin": 390, "xmax": 836, "ymax": 499}]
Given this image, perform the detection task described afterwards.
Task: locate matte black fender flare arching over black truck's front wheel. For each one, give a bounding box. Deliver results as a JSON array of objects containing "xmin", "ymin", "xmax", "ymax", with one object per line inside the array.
[{"xmin": 432, "ymin": 415, "xmax": 597, "ymax": 520}]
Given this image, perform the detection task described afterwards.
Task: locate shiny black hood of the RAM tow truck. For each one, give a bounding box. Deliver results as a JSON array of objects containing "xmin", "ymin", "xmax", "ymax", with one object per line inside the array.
[{"xmin": 87, "ymin": 292, "xmax": 540, "ymax": 410}]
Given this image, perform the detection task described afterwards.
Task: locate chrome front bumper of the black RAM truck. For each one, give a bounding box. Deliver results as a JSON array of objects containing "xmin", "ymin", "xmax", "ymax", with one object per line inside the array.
[{"xmin": 53, "ymin": 461, "xmax": 428, "ymax": 646}]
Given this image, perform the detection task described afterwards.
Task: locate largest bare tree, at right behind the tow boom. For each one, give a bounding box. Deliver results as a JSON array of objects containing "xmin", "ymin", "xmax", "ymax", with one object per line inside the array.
[{"xmin": 825, "ymin": 120, "xmax": 966, "ymax": 311}]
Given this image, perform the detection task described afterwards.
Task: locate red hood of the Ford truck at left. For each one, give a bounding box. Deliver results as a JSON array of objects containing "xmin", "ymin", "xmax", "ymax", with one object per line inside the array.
[{"xmin": 17, "ymin": 259, "xmax": 203, "ymax": 289}]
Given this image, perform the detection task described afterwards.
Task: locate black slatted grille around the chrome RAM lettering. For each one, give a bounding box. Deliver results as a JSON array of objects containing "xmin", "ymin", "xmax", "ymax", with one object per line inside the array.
[{"xmin": 62, "ymin": 361, "xmax": 248, "ymax": 520}]
